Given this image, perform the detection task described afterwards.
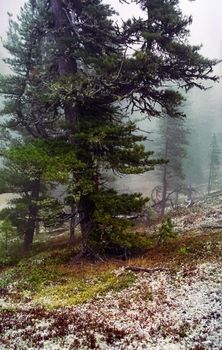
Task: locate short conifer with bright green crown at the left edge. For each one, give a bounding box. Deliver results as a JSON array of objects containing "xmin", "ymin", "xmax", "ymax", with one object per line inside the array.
[{"xmin": 0, "ymin": 140, "xmax": 66, "ymax": 252}]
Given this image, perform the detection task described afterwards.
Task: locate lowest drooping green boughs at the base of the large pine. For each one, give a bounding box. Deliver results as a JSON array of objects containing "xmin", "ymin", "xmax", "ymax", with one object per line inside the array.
[{"xmin": 87, "ymin": 190, "xmax": 149, "ymax": 254}]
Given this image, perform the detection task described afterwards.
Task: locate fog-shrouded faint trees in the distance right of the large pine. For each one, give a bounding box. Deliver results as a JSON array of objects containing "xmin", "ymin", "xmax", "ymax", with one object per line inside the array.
[{"xmin": 116, "ymin": 83, "xmax": 222, "ymax": 213}]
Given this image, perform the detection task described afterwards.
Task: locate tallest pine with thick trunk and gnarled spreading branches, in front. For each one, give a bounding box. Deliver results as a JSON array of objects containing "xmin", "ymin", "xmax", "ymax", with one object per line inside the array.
[{"xmin": 1, "ymin": 0, "xmax": 217, "ymax": 252}]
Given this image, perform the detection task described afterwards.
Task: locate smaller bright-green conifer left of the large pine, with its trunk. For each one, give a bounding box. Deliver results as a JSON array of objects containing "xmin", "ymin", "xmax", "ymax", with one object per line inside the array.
[{"xmin": 0, "ymin": 140, "xmax": 80, "ymax": 251}]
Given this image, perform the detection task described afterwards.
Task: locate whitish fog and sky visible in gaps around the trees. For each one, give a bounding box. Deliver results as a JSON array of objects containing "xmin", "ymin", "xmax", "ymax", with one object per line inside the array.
[{"xmin": 0, "ymin": 0, "xmax": 222, "ymax": 194}]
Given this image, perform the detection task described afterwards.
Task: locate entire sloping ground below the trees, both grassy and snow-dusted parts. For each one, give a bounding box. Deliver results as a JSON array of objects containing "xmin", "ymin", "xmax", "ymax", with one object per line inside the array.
[{"xmin": 0, "ymin": 226, "xmax": 222, "ymax": 350}]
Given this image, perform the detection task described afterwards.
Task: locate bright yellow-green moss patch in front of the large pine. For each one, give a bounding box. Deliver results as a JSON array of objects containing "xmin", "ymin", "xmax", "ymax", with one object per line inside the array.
[{"xmin": 34, "ymin": 273, "xmax": 136, "ymax": 309}]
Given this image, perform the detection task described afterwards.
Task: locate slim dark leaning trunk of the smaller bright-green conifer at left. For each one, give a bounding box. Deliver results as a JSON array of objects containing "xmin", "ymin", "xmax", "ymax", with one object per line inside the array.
[{"xmin": 23, "ymin": 178, "xmax": 40, "ymax": 252}]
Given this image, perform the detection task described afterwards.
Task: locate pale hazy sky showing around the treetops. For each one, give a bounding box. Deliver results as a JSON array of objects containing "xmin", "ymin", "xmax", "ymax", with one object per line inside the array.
[{"xmin": 0, "ymin": 0, "xmax": 222, "ymax": 71}]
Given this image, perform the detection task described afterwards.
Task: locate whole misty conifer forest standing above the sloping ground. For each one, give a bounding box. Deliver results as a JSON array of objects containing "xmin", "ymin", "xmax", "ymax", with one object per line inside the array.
[{"xmin": 0, "ymin": 0, "xmax": 222, "ymax": 255}]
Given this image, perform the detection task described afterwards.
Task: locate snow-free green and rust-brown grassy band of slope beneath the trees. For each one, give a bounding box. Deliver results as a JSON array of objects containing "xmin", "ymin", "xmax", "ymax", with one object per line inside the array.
[{"xmin": 0, "ymin": 230, "xmax": 222, "ymax": 309}]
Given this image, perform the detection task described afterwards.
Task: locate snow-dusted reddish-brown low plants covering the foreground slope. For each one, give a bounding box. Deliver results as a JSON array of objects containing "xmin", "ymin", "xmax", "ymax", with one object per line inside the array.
[{"xmin": 0, "ymin": 262, "xmax": 222, "ymax": 350}]
